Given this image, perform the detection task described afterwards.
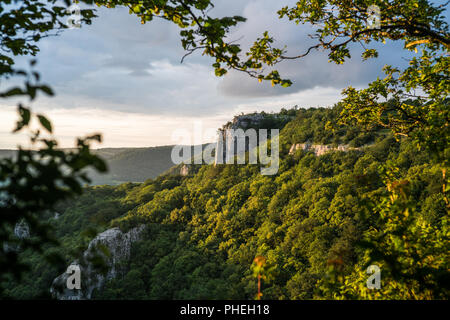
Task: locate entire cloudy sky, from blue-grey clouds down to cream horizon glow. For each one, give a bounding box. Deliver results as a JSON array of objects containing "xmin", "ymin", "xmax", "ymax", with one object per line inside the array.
[{"xmin": 0, "ymin": 0, "xmax": 414, "ymax": 148}]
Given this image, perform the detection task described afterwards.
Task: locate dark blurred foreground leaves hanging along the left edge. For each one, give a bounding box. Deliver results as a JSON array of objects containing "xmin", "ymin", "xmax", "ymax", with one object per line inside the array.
[{"xmin": 0, "ymin": 0, "xmax": 106, "ymax": 294}]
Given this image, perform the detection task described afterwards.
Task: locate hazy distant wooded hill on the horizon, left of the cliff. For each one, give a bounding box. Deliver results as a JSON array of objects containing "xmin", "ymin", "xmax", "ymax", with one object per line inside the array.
[{"xmin": 0, "ymin": 146, "xmax": 206, "ymax": 185}]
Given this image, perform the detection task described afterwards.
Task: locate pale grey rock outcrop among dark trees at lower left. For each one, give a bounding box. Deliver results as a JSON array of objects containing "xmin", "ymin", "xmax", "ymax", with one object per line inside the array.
[{"xmin": 50, "ymin": 226, "xmax": 144, "ymax": 300}]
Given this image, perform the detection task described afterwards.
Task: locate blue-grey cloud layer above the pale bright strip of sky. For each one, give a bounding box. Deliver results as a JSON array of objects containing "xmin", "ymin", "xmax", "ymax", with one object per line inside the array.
[{"xmin": 24, "ymin": 0, "xmax": 410, "ymax": 115}]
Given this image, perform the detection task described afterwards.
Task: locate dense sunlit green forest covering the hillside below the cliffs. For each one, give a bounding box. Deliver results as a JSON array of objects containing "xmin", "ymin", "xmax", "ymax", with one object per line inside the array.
[{"xmin": 5, "ymin": 105, "xmax": 450, "ymax": 299}]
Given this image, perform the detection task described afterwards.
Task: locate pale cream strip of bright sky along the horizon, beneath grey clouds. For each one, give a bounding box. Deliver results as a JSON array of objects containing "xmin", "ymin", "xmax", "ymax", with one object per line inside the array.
[{"xmin": 0, "ymin": 87, "xmax": 339, "ymax": 149}]
